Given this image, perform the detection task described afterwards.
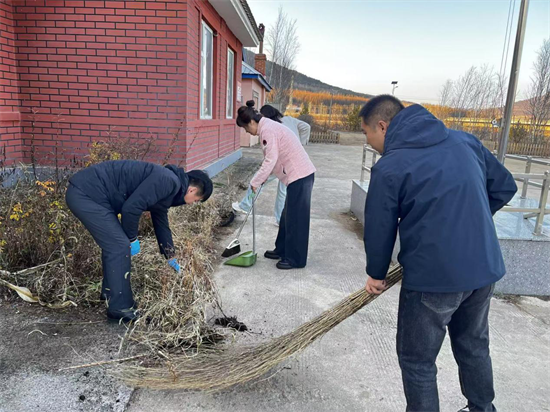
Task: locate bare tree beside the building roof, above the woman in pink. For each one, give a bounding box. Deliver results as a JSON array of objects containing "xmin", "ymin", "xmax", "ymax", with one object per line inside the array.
[{"xmin": 266, "ymin": 6, "xmax": 300, "ymax": 113}]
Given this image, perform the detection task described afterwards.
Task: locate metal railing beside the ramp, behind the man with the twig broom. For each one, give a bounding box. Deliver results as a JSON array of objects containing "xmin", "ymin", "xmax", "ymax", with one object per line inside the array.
[{"xmin": 361, "ymin": 145, "xmax": 550, "ymax": 235}]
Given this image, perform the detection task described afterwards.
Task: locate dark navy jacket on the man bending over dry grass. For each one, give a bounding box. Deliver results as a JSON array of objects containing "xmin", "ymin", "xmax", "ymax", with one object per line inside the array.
[{"xmin": 70, "ymin": 160, "xmax": 189, "ymax": 258}]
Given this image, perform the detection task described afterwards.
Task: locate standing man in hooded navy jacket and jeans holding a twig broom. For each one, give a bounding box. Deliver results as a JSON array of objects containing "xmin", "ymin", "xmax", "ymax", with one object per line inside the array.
[{"xmin": 360, "ymin": 95, "xmax": 517, "ymax": 412}]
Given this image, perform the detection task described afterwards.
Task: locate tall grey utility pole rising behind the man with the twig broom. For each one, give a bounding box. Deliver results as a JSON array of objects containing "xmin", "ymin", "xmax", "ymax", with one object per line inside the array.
[{"xmin": 497, "ymin": 0, "xmax": 529, "ymax": 163}]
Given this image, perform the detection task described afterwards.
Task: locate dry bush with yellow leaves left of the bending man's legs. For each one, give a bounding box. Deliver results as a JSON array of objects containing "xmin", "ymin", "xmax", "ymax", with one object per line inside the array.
[{"xmin": 0, "ymin": 166, "xmax": 101, "ymax": 305}]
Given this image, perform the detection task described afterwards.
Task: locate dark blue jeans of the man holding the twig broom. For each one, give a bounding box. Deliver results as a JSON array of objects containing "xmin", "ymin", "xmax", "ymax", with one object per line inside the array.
[{"xmin": 397, "ymin": 284, "xmax": 496, "ymax": 412}]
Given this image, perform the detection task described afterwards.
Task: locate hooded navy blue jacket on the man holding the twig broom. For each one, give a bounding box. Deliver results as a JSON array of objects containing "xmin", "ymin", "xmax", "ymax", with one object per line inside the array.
[{"xmin": 364, "ymin": 105, "xmax": 517, "ymax": 292}]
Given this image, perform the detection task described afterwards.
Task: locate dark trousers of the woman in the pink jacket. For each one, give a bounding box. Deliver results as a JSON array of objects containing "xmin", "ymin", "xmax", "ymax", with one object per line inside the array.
[{"xmin": 275, "ymin": 173, "xmax": 315, "ymax": 268}]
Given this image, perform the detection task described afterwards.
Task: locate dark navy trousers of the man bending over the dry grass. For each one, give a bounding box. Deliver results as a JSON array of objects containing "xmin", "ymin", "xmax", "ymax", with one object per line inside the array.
[{"xmin": 66, "ymin": 185, "xmax": 135, "ymax": 311}]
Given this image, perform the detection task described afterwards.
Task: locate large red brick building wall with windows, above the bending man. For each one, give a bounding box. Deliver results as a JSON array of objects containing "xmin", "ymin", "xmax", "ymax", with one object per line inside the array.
[{"xmin": 0, "ymin": 0, "xmax": 242, "ymax": 167}]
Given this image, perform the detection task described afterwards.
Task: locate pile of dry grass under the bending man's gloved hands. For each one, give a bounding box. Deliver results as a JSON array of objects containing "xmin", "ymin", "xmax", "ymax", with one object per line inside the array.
[{"xmin": 126, "ymin": 197, "xmax": 233, "ymax": 355}]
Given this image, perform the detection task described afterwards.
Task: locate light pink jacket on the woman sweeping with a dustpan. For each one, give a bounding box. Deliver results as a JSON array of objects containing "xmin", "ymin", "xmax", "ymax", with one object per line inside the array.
[{"xmin": 250, "ymin": 117, "xmax": 316, "ymax": 187}]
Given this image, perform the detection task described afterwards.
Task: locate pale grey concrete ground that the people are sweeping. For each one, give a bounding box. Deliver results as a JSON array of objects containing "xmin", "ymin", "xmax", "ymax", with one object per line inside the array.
[{"xmin": 0, "ymin": 145, "xmax": 550, "ymax": 412}]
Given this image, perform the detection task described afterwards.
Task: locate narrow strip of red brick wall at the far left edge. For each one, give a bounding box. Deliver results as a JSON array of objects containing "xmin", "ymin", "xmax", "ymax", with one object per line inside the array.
[{"xmin": 0, "ymin": 0, "xmax": 23, "ymax": 163}]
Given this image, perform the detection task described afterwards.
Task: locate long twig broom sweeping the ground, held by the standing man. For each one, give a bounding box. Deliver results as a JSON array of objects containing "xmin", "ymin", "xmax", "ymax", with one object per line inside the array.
[{"xmin": 115, "ymin": 266, "xmax": 403, "ymax": 391}]
